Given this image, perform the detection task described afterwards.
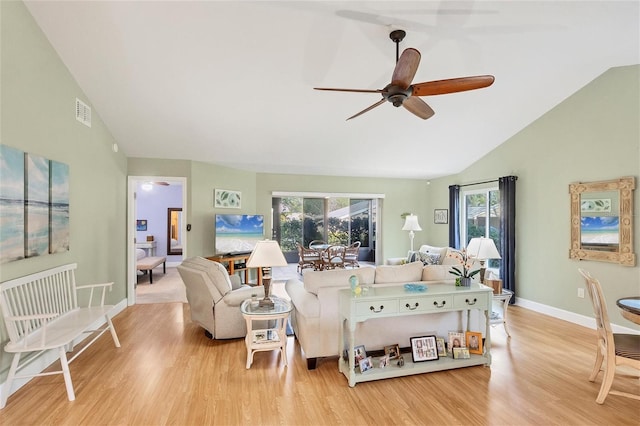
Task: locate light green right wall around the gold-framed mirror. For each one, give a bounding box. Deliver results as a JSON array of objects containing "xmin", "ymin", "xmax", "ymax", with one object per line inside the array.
[{"xmin": 422, "ymin": 65, "xmax": 640, "ymax": 327}]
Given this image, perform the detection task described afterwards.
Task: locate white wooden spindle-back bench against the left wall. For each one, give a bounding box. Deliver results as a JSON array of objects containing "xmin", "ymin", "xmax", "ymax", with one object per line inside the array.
[{"xmin": 0, "ymin": 263, "xmax": 120, "ymax": 408}]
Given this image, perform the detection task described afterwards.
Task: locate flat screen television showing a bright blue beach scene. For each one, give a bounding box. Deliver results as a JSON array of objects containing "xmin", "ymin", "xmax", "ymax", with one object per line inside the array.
[{"xmin": 215, "ymin": 214, "xmax": 264, "ymax": 255}]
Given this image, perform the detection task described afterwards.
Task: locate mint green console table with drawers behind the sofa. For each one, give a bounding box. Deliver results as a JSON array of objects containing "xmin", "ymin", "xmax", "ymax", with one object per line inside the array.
[{"xmin": 338, "ymin": 284, "xmax": 493, "ymax": 387}]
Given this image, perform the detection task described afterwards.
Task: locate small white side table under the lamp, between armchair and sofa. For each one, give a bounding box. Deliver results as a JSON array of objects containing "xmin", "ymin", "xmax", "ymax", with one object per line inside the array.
[{"xmin": 240, "ymin": 296, "xmax": 292, "ymax": 369}]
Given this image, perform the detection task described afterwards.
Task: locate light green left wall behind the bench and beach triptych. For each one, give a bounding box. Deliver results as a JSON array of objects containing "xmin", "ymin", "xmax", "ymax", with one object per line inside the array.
[{"xmin": 0, "ymin": 1, "xmax": 127, "ymax": 377}]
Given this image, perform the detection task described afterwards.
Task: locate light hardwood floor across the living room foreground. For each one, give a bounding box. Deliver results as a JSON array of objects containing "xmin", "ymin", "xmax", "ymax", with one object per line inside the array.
[{"xmin": 0, "ymin": 303, "xmax": 640, "ymax": 426}]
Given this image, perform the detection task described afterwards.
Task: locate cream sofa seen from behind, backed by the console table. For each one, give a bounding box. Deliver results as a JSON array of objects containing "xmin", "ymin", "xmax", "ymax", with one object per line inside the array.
[{"xmin": 285, "ymin": 262, "xmax": 484, "ymax": 369}]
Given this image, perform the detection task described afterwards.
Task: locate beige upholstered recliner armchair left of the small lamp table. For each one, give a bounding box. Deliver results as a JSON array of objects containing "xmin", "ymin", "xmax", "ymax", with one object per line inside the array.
[{"xmin": 178, "ymin": 257, "xmax": 264, "ymax": 339}]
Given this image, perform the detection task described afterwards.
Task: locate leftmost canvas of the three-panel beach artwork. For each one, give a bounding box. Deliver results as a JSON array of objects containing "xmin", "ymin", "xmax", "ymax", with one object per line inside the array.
[{"xmin": 0, "ymin": 145, "xmax": 24, "ymax": 263}]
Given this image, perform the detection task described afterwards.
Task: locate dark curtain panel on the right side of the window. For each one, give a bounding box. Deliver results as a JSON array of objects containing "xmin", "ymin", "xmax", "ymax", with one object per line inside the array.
[{"xmin": 498, "ymin": 176, "xmax": 518, "ymax": 304}]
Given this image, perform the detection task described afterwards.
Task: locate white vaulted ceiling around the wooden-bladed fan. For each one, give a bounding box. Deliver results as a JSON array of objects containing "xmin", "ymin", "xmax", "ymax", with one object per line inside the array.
[{"xmin": 26, "ymin": 0, "xmax": 640, "ymax": 179}]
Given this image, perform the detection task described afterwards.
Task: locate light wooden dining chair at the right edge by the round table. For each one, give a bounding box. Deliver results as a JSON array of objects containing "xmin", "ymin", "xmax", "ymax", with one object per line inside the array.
[{"xmin": 578, "ymin": 268, "xmax": 640, "ymax": 404}]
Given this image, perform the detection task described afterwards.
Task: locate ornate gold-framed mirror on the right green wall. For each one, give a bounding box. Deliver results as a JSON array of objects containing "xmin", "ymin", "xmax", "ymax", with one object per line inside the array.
[{"xmin": 569, "ymin": 176, "xmax": 636, "ymax": 266}]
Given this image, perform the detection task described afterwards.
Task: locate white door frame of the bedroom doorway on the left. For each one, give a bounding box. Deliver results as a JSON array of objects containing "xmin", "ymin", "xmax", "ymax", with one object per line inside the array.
[{"xmin": 127, "ymin": 176, "xmax": 189, "ymax": 306}]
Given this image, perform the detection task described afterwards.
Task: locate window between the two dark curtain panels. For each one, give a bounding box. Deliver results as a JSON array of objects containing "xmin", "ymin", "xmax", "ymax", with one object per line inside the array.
[{"xmin": 461, "ymin": 187, "xmax": 502, "ymax": 269}]
